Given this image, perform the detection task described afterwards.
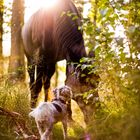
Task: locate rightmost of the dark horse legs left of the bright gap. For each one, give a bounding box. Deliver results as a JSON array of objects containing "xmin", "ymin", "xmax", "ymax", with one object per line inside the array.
[{"xmin": 43, "ymin": 63, "xmax": 55, "ymax": 101}]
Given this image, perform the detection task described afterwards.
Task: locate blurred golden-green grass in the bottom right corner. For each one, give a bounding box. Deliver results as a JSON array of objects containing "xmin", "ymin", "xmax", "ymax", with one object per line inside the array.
[{"xmin": 88, "ymin": 83, "xmax": 140, "ymax": 140}]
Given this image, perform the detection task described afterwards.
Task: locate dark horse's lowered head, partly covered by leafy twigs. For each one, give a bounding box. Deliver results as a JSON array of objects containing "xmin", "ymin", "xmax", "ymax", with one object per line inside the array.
[{"xmin": 66, "ymin": 54, "xmax": 99, "ymax": 122}]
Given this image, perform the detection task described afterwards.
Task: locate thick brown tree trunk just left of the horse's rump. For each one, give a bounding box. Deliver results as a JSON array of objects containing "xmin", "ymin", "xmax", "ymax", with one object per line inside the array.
[{"xmin": 9, "ymin": 0, "xmax": 25, "ymax": 80}]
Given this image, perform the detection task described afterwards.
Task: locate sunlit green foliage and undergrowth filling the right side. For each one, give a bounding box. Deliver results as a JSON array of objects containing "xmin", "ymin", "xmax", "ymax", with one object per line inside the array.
[{"xmin": 83, "ymin": 0, "xmax": 140, "ymax": 140}]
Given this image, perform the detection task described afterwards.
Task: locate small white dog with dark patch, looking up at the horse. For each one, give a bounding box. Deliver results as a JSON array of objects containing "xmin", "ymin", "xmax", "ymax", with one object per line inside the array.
[{"xmin": 29, "ymin": 86, "xmax": 72, "ymax": 140}]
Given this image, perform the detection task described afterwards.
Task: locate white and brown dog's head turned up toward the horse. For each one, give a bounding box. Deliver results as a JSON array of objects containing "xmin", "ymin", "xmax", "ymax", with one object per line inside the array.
[{"xmin": 53, "ymin": 86, "xmax": 72, "ymax": 101}]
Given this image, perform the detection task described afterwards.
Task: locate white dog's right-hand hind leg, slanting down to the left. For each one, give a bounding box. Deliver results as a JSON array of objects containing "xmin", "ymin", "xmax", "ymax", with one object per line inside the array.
[{"xmin": 41, "ymin": 123, "xmax": 53, "ymax": 140}]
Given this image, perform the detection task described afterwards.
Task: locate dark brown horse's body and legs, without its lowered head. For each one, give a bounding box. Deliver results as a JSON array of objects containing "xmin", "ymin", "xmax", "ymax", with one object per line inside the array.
[{"xmin": 22, "ymin": 0, "xmax": 87, "ymax": 107}]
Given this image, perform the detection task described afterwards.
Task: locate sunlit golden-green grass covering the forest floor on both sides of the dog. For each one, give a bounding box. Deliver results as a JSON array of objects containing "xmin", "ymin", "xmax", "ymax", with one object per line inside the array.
[{"xmin": 0, "ymin": 78, "xmax": 140, "ymax": 140}]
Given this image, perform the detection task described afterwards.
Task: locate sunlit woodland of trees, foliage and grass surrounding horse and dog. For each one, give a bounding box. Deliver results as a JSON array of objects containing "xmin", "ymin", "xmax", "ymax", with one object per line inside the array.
[{"xmin": 0, "ymin": 0, "xmax": 140, "ymax": 140}]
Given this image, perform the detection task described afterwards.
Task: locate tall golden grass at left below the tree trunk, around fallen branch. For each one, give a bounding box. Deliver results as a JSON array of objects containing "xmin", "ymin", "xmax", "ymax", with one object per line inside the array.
[{"xmin": 0, "ymin": 77, "xmax": 30, "ymax": 140}]
